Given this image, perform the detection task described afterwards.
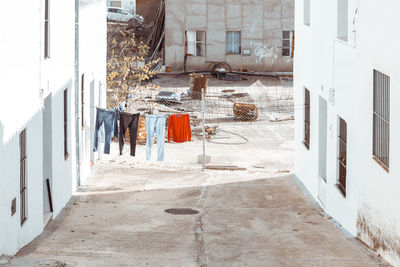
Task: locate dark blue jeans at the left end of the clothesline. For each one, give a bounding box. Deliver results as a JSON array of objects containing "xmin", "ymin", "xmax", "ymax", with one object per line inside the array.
[{"xmin": 93, "ymin": 108, "xmax": 119, "ymax": 154}]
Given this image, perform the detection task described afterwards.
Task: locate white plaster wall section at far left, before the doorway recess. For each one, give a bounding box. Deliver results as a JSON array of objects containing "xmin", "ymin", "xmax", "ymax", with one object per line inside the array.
[{"xmin": 0, "ymin": 0, "xmax": 43, "ymax": 255}]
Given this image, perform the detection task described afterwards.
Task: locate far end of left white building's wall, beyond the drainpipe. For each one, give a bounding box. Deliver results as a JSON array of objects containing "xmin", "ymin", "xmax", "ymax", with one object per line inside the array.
[{"xmin": 79, "ymin": 0, "xmax": 107, "ymax": 182}]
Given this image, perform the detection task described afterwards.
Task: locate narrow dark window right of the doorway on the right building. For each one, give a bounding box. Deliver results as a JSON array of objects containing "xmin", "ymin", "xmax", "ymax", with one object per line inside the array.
[{"xmin": 337, "ymin": 117, "xmax": 347, "ymax": 197}]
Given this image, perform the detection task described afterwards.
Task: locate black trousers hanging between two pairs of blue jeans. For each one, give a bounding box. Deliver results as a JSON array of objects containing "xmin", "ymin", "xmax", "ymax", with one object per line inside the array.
[{"xmin": 119, "ymin": 112, "xmax": 140, "ymax": 157}]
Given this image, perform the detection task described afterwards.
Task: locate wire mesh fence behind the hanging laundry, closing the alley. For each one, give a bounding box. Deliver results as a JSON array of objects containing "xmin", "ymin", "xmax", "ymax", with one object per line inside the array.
[{"xmin": 102, "ymin": 76, "xmax": 294, "ymax": 172}]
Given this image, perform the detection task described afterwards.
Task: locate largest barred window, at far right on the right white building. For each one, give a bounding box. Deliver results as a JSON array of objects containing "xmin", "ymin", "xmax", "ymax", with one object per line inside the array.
[{"xmin": 373, "ymin": 70, "xmax": 390, "ymax": 171}]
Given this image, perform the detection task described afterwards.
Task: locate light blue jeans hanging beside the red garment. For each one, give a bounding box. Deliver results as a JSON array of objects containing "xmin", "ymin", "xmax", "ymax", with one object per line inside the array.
[{"xmin": 146, "ymin": 115, "xmax": 167, "ymax": 161}]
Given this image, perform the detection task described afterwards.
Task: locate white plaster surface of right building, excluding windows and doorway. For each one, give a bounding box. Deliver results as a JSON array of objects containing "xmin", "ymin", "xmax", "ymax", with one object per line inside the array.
[{"xmin": 294, "ymin": 0, "xmax": 400, "ymax": 265}]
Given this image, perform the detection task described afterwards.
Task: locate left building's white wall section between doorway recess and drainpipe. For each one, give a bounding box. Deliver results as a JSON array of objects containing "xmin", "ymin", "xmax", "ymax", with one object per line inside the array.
[{"xmin": 41, "ymin": 1, "xmax": 76, "ymax": 218}]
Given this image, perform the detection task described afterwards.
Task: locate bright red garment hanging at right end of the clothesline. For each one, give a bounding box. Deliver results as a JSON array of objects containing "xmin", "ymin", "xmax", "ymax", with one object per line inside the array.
[{"xmin": 168, "ymin": 114, "xmax": 192, "ymax": 143}]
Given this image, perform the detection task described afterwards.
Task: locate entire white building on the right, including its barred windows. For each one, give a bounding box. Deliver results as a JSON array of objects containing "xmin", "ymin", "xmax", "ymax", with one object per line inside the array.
[{"xmin": 294, "ymin": 0, "xmax": 400, "ymax": 266}]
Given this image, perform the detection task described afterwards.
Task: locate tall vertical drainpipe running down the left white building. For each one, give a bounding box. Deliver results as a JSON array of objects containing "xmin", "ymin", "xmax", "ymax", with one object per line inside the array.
[{"xmin": 75, "ymin": 0, "xmax": 81, "ymax": 187}]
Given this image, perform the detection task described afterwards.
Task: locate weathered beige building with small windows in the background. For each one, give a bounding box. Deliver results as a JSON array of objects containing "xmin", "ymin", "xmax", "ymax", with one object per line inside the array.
[{"xmin": 165, "ymin": 0, "xmax": 294, "ymax": 72}]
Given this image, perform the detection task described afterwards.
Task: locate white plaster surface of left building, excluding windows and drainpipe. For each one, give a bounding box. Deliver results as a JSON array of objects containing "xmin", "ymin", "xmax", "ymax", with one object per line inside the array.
[{"xmin": 0, "ymin": 0, "xmax": 106, "ymax": 256}]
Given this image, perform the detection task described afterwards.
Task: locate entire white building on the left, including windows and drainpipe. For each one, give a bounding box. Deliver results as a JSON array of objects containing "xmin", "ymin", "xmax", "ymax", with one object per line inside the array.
[{"xmin": 0, "ymin": 0, "xmax": 106, "ymax": 256}]
